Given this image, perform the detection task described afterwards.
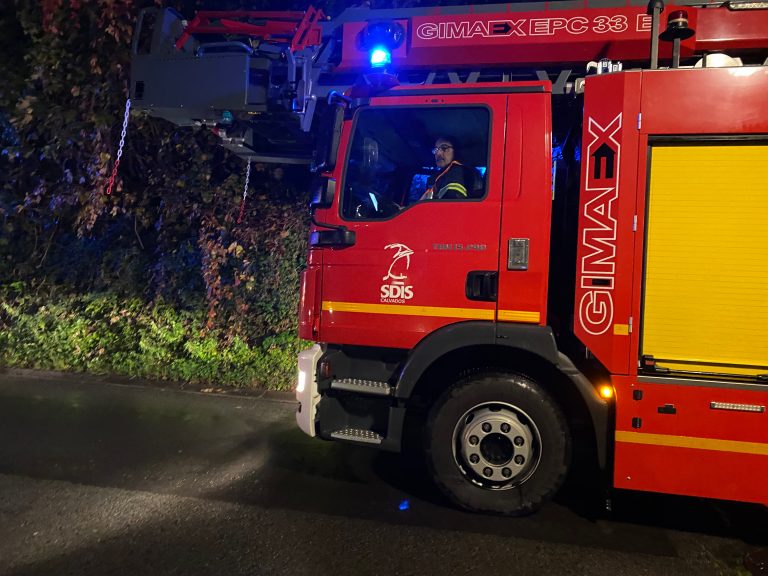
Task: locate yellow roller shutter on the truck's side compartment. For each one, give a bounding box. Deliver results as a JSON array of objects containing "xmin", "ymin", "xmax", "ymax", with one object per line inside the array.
[{"xmin": 641, "ymin": 144, "xmax": 768, "ymax": 374}]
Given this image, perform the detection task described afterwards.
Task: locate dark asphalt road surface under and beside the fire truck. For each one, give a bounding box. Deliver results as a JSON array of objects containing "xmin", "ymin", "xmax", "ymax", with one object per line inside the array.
[{"xmin": 0, "ymin": 373, "xmax": 768, "ymax": 576}]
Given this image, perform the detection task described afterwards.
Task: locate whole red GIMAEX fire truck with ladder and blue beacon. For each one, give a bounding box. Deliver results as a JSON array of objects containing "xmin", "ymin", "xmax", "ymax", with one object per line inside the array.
[{"xmin": 131, "ymin": 0, "xmax": 768, "ymax": 515}]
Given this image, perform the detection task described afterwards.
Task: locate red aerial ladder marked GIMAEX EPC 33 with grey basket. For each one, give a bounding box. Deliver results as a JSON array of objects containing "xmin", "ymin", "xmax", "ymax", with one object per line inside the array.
[{"xmin": 130, "ymin": 1, "xmax": 768, "ymax": 164}]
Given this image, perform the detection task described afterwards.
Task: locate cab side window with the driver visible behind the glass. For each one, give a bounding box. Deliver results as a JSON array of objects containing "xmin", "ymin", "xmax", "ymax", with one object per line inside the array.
[{"xmin": 342, "ymin": 106, "xmax": 490, "ymax": 220}]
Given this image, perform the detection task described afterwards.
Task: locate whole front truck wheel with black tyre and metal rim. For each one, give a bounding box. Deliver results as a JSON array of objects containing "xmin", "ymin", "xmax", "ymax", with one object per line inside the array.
[{"xmin": 425, "ymin": 372, "xmax": 571, "ymax": 516}]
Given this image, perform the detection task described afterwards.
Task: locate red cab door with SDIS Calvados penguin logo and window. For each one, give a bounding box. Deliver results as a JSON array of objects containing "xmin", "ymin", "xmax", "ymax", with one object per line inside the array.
[{"xmin": 317, "ymin": 91, "xmax": 508, "ymax": 348}]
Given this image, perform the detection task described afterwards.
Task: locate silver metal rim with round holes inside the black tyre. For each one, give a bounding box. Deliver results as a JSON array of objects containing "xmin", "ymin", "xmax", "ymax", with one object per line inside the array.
[{"xmin": 453, "ymin": 402, "xmax": 541, "ymax": 490}]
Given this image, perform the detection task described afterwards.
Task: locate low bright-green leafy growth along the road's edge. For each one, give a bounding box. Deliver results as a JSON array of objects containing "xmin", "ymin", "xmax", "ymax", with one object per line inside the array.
[{"xmin": 0, "ymin": 283, "xmax": 305, "ymax": 390}]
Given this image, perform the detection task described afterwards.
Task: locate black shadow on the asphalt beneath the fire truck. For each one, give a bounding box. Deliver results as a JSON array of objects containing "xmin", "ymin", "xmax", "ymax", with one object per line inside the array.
[{"xmin": 246, "ymin": 430, "xmax": 768, "ymax": 555}]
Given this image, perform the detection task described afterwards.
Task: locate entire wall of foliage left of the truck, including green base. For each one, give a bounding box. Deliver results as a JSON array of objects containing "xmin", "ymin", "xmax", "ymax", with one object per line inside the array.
[{"xmin": 0, "ymin": 0, "xmax": 307, "ymax": 387}]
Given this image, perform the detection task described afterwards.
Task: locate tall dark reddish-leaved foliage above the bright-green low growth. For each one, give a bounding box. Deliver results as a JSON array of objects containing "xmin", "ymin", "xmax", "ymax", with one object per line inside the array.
[{"xmin": 0, "ymin": 0, "xmax": 308, "ymax": 336}]
